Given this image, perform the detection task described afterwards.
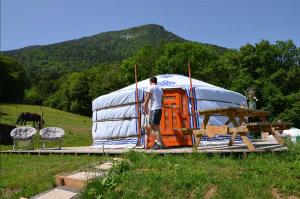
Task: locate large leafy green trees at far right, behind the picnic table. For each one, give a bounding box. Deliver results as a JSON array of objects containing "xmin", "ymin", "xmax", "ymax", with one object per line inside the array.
[{"xmin": 216, "ymin": 40, "xmax": 300, "ymax": 127}]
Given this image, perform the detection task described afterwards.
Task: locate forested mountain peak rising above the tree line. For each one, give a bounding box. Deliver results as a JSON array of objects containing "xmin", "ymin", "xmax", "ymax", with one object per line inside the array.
[{"xmin": 2, "ymin": 24, "xmax": 225, "ymax": 82}]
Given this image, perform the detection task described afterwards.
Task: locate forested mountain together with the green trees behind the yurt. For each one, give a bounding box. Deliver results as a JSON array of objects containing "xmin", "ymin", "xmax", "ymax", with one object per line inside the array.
[{"xmin": 1, "ymin": 25, "xmax": 300, "ymax": 127}]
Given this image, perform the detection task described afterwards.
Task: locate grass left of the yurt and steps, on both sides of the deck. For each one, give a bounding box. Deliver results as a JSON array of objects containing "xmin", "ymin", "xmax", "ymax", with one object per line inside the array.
[{"xmin": 0, "ymin": 104, "xmax": 105, "ymax": 198}]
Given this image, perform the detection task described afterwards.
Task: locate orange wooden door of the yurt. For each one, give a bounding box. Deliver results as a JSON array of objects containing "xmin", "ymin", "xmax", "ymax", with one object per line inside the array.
[{"xmin": 149, "ymin": 88, "xmax": 192, "ymax": 147}]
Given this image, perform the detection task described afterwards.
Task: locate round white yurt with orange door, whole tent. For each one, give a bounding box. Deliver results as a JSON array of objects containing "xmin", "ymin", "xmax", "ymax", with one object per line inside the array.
[{"xmin": 92, "ymin": 74, "xmax": 247, "ymax": 148}]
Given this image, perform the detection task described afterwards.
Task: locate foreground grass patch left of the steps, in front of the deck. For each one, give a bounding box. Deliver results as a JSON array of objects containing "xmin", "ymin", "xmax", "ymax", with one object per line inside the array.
[{"xmin": 0, "ymin": 154, "xmax": 107, "ymax": 198}]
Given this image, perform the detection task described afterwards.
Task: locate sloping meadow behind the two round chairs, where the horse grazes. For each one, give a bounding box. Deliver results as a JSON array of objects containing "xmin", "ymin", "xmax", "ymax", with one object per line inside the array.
[{"xmin": 0, "ymin": 104, "xmax": 92, "ymax": 150}]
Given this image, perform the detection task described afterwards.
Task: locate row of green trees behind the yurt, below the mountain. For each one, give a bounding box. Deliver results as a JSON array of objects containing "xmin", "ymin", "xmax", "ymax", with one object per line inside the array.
[{"xmin": 0, "ymin": 40, "xmax": 300, "ymax": 127}]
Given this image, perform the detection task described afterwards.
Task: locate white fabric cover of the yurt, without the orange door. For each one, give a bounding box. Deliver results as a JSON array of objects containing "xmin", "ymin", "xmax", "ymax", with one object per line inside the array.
[{"xmin": 92, "ymin": 74, "xmax": 247, "ymax": 148}]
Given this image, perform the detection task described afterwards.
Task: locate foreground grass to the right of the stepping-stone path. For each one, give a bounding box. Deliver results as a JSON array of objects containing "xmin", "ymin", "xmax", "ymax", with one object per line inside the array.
[{"xmin": 82, "ymin": 145, "xmax": 300, "ymax": 199}]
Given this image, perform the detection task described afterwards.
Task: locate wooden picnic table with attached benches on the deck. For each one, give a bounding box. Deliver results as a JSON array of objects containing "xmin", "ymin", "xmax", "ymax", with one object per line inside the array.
[{"xmin": 186, "ymin": 107, "xmax": 291, "ymax": 151}]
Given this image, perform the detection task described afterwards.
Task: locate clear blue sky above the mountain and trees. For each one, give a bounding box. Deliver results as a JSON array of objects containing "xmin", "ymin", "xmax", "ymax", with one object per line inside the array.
[{"xmin": 1, "ymin": 0, "xmax": 300, "ymax": 50}]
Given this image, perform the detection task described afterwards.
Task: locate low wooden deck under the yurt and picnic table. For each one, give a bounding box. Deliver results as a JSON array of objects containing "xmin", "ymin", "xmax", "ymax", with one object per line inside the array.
[{"xmin": 1, "ymin": 141, "xmax": 288, "ymax": 155}]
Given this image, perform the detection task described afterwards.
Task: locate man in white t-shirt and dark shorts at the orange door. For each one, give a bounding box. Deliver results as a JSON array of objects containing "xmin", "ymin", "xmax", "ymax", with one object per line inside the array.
[{"xmin": 143, "ymin": 77, "xmax": 165, "ymax": 149}]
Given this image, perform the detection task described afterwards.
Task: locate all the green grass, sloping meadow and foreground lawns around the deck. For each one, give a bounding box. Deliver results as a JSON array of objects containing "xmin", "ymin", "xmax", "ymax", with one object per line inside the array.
[{"xmin": 0, "ymin": 104, "xmax": 300, "ymax": 199}]
